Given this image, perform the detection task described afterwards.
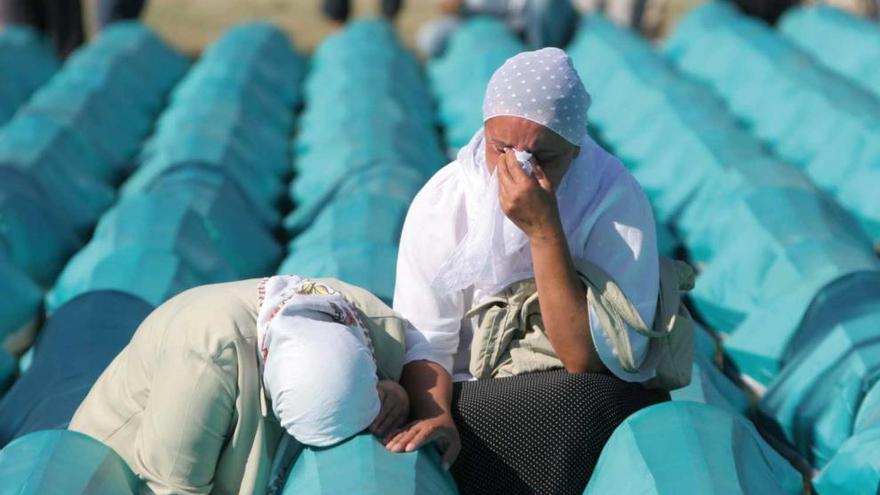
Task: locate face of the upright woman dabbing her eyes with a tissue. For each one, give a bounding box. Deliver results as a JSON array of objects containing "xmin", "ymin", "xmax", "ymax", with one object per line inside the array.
[{"xmin": 485, "ymin": 115, "xmax": 580, "ymax": 188}]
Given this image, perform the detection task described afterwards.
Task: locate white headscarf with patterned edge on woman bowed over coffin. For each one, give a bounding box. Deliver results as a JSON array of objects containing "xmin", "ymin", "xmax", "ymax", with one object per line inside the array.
[{"xmin": 257, "ymin": 275, "xmax": 380, "ymax": 447}]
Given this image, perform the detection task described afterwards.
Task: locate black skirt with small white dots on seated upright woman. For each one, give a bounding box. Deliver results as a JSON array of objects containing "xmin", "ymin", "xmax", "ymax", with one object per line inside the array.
[{"xmin": 452, "ymin": 370, "xmax": 669, "ymax": 495}]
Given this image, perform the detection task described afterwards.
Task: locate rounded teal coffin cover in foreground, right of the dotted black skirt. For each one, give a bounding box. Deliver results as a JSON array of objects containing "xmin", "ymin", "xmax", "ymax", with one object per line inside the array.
[{"xmin": 584, "ymin": 402, "xmax": 802, "ymax": 495}]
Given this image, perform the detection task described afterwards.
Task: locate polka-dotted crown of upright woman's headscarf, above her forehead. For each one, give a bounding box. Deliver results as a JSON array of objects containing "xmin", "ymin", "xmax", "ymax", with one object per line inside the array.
[{"xmin": 483, "ymin": 48, "xmax": 590, "ymax": 146}]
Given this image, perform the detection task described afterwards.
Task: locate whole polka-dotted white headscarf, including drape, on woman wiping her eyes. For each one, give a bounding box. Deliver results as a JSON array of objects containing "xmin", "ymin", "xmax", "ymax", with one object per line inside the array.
[{"xmin": 432, "ymin": 48, "xmax": 595, "ymax": 294}]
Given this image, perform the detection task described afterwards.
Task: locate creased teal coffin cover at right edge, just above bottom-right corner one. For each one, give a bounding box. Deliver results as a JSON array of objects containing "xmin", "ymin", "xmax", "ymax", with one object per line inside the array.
[{"xmin": 759, "ymin": 272, "xmax": 880, "ymax": 468}]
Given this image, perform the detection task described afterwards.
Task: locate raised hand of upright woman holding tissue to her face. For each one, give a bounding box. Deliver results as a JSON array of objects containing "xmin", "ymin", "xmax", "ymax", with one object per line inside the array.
[{"xmin": 498, "ymin": 149, "xmax": 561, "ymax": 242}]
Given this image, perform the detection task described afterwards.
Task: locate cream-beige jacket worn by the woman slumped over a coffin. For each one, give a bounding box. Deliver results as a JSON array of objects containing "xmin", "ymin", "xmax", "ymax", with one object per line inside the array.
[{"xmin": 70, "ymin": 279, "xmax": 407, "ymax": 494}]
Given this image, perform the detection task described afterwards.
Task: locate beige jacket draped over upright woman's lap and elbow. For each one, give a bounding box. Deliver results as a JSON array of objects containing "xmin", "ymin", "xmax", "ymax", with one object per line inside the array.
[{"xmin": 467, "ymin": 257, "xmax": 694, "ymax": 390}]
